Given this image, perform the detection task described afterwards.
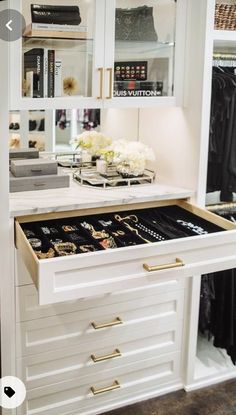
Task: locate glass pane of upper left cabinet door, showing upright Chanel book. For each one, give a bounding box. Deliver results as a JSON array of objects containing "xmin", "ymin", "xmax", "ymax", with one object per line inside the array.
[{"xmin": 22, "ymin": 0, "xmax": 95, "ymax": 98}]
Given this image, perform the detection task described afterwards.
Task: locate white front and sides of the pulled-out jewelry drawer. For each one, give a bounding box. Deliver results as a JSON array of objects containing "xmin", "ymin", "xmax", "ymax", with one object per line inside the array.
[{"xmin": 16, "ymin": 202, "xmax": 236, "ymax": 305}]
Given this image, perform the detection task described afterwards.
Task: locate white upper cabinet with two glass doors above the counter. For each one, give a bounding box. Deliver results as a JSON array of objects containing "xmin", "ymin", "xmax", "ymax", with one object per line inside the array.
[{"xmin": 9, "ymin": 0, "xmax": 186, "ymax": 110}]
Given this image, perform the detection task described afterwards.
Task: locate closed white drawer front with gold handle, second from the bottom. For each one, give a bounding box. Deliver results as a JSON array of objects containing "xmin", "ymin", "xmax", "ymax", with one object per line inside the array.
[{"xmin": 17, "ymin": 320, "xmax": 183, "ymax": 390}]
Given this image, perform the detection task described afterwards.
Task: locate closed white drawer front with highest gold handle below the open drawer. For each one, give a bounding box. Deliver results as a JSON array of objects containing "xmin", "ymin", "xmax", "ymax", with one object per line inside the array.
[{"xmin": 16, "ymin": 291, "xmax": 184, "ymax": 357}]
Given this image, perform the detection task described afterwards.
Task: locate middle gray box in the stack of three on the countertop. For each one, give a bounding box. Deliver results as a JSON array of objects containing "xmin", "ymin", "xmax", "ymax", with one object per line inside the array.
[{"xmin": 11, "ymin": 159, "xmax": 57, "ymax": 177}]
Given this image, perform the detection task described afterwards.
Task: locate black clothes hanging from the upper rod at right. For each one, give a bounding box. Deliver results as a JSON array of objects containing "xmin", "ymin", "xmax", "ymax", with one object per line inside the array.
[{"xmin": 207, "ymin": 68, "xmax": 236, "ymax": 201}]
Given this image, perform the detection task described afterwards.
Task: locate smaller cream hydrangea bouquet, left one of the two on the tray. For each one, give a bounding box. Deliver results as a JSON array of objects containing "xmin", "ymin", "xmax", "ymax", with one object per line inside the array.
[{"xmin": 71, "ymin": 131, "xmax": 112, "ymax": 157}]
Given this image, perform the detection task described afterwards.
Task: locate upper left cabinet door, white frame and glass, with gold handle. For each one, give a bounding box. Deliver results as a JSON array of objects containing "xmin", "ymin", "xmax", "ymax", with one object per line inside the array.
[{"xmin": 9, "ymin": 0, "xmax": 105, "ymax": 108}]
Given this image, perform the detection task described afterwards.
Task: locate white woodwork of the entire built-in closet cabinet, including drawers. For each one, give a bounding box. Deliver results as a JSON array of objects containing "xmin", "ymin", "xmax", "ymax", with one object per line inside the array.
[{"xmin": 0, "ymin": 0, "xmax": 236, "ymax": 415}]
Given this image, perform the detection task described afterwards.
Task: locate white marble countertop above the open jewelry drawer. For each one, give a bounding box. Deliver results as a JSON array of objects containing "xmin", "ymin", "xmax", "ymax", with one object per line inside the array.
[{"xmin": 10, "ymin": 174, "xmax": 194, "ymax": 217}]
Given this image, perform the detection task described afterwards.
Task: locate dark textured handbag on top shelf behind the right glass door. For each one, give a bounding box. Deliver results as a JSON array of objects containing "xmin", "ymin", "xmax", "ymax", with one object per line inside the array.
[{"xmin": 115, "ymin": 6, "xmax": 158, "ymax": 41}]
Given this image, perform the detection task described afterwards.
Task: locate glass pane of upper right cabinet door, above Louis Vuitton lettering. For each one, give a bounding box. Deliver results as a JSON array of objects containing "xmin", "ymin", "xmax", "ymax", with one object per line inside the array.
[{"xmin": 114, "ymin": 0, "xmax": 176, "ymax": 97}]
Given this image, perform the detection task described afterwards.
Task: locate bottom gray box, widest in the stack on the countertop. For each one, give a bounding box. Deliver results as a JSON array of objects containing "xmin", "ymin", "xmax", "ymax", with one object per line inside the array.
[{"xmin": 10, "ymin": 173, "xmax": 70, "ymax": 193}]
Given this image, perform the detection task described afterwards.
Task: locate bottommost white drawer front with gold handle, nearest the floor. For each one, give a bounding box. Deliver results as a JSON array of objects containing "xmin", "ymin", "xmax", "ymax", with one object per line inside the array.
[{"xmin": 17, "ymin": 353, "xmax": 181, "ymax": 415}]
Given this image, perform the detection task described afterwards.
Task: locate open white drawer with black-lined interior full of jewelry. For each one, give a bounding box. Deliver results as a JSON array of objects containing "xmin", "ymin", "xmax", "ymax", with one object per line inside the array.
[{"xmin": 15, "ymin": 200, "xmax": 236, "ymax": 305}]
